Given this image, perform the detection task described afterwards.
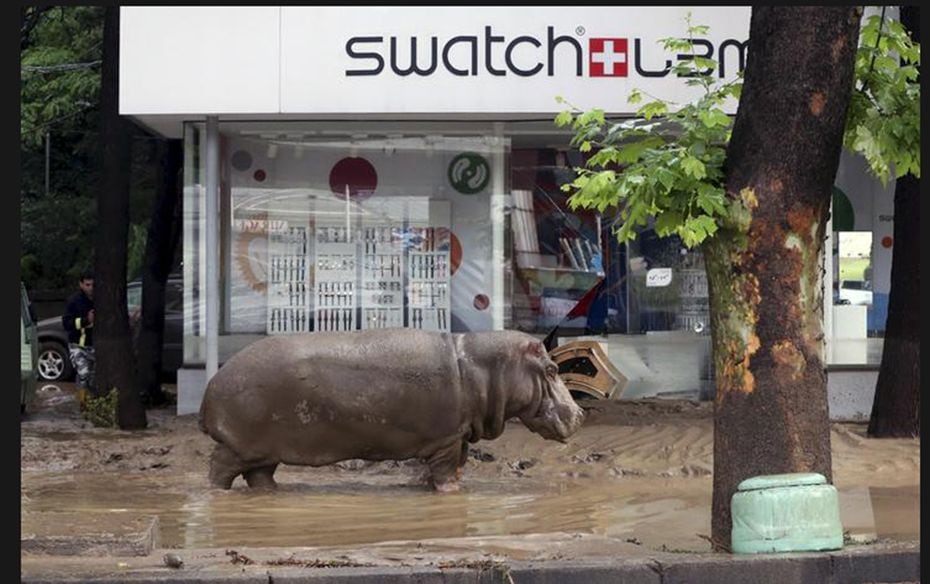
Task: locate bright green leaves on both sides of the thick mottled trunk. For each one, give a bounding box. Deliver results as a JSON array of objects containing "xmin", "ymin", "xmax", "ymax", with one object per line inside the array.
[{"xmin": 555, "ymin": 9, "xmax": 920, "ymax": 248}]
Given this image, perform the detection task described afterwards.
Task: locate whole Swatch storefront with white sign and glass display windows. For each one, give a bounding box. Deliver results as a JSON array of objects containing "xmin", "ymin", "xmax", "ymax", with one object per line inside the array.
[{"xmin": 120, "ymin": 6, "xmax": 890, "ymax": 413}]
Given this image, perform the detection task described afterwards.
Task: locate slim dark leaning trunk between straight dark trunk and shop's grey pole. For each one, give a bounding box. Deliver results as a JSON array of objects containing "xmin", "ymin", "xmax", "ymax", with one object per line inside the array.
[{"xmin": 136, "ymin": 140, "xmax": 183, "ymax": 405}]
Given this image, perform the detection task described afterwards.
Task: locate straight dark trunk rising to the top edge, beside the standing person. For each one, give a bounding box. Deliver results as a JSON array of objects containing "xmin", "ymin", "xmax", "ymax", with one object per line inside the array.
[{"xmin": 94, "ymin": 6, "xmax": 146, "ymax": 429}]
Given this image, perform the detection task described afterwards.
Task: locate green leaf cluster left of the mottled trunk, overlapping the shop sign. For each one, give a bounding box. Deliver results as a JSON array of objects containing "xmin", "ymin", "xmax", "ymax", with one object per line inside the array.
[{"xmin": 555, "ymin": 15, "xmax": 744, "ymax": 248}]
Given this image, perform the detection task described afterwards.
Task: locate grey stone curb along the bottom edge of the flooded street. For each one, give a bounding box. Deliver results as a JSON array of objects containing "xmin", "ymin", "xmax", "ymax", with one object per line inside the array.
[{"xmin": 22, "ymin": 542, "xmax": 920, "ymax": 584}]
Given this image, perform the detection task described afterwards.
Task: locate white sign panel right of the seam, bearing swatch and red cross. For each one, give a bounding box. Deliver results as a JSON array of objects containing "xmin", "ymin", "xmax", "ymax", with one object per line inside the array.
[{"xmin": 281, "ymin": 6, "xmax": 750, "ymax": 113}]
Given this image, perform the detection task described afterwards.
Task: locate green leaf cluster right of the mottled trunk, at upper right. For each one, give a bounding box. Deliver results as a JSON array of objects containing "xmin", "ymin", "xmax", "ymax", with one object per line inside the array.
[{"xmin": 843, "ymin": 9, "xmax": 920, "ymax": 184}]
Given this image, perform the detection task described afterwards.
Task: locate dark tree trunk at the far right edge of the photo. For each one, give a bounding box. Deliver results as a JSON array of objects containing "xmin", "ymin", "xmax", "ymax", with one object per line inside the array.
[{"xmin": 869, "ymin": 6, "xmax": 920, "ymax": 438}]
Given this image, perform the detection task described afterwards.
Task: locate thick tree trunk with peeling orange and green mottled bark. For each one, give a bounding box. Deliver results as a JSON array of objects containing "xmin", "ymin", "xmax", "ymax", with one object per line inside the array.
[{"xmin": 705, "ymin": 6, "xmax": 861, "ymax": 550}]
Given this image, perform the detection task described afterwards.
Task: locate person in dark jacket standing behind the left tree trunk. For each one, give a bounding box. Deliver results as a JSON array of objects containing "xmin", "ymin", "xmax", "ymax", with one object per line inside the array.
[{"xmin": 61, "ymin": 271, "xmax": 96, "ymax": 408}]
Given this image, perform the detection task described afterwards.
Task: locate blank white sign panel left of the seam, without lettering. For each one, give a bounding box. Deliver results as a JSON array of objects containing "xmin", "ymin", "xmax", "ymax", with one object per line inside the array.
[{"xmin": 119, "ymin": 6, "xmax": 281, "ymax": 114}]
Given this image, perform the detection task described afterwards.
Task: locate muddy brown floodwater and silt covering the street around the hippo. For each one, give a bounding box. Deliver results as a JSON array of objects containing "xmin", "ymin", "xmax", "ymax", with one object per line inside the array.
[{"xmin": 21, "ymin": 385, "xmax": 920, "ymax": 557}]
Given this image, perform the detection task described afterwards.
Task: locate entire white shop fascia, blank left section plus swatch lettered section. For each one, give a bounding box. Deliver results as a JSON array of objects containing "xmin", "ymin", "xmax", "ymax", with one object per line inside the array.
[{"xmin": 120, "ymin": 6, "xmax": 750, "ymax": 115}]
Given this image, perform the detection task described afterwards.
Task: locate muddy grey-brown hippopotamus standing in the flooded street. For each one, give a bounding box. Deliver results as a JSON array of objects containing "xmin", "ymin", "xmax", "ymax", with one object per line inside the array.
[{"xmin": 200, "ymin": 329, "xmax": 584, "ymax": 491}]
